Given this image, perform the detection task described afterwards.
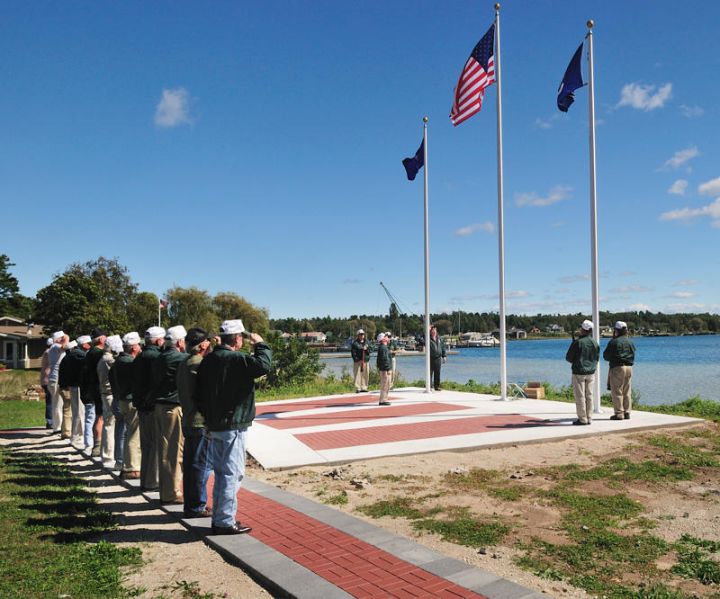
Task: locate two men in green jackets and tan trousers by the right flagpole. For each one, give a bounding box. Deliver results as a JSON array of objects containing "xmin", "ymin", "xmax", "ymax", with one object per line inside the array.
[{"xmin": 565, "ymin": 320, "xmax": 635, "ymax": 425}]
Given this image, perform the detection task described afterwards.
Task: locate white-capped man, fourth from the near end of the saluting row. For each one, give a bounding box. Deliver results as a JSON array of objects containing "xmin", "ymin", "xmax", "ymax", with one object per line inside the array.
[{"xmin": 132, "ymin": 327, "xmax": 165, "ymax": 491}]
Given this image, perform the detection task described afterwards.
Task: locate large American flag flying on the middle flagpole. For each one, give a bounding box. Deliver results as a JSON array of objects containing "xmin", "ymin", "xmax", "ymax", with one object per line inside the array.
[{"xmin": 450, "ymin": 23, "xmax": 495, "ymax": 126}]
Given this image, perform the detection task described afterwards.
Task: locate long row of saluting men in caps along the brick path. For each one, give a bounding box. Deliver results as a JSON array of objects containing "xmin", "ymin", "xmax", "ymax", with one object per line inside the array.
[{"xmin": 40, "ymin": 319, "xmax": 272, "ymax": 534}]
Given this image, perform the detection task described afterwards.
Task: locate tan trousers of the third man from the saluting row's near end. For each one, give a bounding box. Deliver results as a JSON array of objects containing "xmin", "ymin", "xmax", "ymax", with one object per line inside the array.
[{"xmin": 155, "ymin": 403, "xmax": 184, "ymax": 502}]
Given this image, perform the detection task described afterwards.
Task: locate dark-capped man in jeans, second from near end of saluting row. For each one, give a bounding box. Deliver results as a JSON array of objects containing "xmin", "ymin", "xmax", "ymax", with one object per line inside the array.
[{"xmin": 177, "ymin": 327, "xmax": 210, "ymax": 518}]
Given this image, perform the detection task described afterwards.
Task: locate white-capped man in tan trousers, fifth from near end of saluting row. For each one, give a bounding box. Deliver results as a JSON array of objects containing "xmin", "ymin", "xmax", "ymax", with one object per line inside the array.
[{"xmin": 110, "ymin": 331, "xmax": 140, "ymax": 480}]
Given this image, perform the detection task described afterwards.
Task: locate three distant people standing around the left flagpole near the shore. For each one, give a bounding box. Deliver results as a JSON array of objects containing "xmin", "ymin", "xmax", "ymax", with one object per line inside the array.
[{"xmin": 350, "ymin": 326, "xmax": 447, "ymax": 406}]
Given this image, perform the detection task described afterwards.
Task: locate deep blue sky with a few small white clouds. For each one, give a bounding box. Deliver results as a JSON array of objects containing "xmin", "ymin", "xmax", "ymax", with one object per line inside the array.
[{"xmin": 0, "ymin": 0, "xmax": 720, "ymax": 317}]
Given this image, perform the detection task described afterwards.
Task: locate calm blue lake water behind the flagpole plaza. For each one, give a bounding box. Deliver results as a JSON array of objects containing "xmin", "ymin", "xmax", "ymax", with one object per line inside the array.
[{"xmin": 325, "ymin": 335, "xmax": 720, "ymax": 405}]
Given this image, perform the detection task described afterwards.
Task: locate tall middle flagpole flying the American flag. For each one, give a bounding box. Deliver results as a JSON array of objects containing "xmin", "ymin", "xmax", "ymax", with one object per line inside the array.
[{"xmin": 494, "ymin": 4, "xmax": 508, "ymax": 401}]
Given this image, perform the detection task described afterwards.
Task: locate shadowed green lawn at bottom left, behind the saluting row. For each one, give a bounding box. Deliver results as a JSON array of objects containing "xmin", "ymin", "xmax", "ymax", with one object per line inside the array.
[{"xmin": 0, "ymin": 451, "xmax": 142, "ymax": 598}]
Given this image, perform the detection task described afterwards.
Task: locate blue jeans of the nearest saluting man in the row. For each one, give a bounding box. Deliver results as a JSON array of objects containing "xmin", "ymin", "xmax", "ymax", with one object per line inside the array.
[{"xmin": 210, "ymin": 428, "xmax": 247, "ymax": 526}]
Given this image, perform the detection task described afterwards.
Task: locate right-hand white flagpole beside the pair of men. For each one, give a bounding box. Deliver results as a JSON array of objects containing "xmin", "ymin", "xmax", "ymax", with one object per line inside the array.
[{"xmin": 587, "ymin": 20, "xmax": 600, "ymax": 414}]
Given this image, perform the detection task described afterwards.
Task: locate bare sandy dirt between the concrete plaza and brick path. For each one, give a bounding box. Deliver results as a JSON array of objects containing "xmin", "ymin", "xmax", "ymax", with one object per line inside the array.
[{"xmin": 248, "ymin": 424, "xmax": 720, "ymax": 597}]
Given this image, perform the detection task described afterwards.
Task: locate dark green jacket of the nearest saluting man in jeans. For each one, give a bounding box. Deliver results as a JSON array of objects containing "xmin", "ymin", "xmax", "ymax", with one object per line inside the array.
[{"xmin": 193, "ymin": 343, "xmax": 272, "ymax": 431}]
